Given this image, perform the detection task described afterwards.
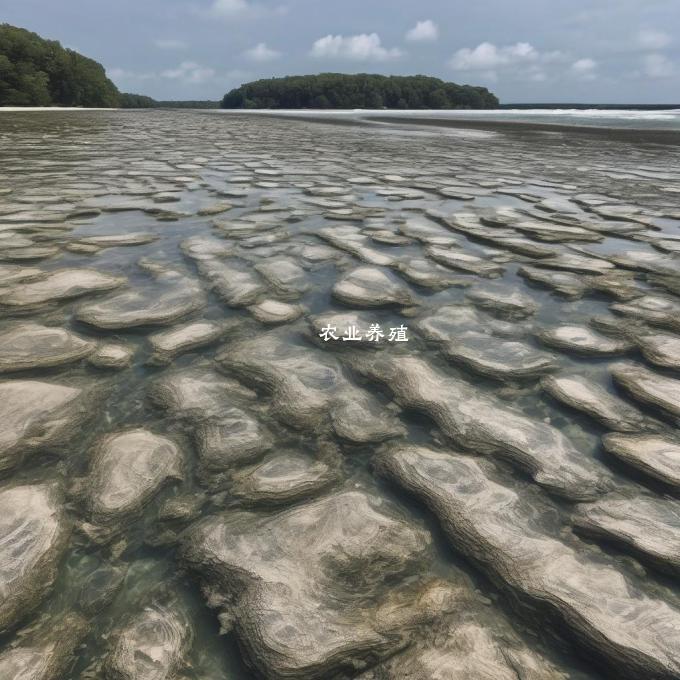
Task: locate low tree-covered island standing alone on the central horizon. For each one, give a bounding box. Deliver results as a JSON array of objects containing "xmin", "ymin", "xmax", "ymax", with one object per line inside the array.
[{"xmin": 222, "ymin": 73, "xmax": 498, "ymax": 109}]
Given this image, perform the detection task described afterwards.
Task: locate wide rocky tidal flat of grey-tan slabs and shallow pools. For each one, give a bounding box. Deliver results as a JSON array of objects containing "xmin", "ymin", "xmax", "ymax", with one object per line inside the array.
[{"xmin": 0, "ymin": 110, "xmax": 680, "ymax": 680}]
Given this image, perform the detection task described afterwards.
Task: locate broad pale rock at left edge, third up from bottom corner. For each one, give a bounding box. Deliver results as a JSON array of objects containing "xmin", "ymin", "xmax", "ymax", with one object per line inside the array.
[{"xmin": 0, "ymin": 380, "xmax": 96, "ymax": 473}]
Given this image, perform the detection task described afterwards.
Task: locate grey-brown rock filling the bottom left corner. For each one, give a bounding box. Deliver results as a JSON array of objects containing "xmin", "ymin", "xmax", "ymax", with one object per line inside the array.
[{"xmin": 0, "ymin": 614, "xmax": 88, "ymax": 680}]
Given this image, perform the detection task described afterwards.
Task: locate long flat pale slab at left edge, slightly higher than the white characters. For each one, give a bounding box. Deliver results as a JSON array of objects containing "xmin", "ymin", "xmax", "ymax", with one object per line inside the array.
[{"xmin": 0, "ymin": 269, "xmax": 125, "ymax": 308}]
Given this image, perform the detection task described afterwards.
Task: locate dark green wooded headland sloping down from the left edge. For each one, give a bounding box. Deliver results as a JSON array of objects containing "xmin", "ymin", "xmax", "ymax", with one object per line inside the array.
[{"xmin": 0, "ymin": 24, "xmax": 120, "ymax": 107}]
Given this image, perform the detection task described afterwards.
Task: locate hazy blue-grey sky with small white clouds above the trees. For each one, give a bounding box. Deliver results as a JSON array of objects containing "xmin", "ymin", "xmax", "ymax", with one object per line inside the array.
[{"xmin": 5, "ymin": 0, "xmax": 680, "ymax": 103}]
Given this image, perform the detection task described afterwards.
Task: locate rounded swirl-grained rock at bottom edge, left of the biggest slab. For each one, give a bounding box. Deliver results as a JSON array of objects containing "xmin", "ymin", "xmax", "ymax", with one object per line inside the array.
[{"xmin": 104, "ymin": 603, "xmax": 193, "ymax": 680}]
